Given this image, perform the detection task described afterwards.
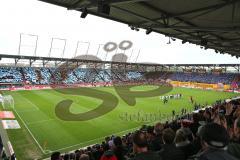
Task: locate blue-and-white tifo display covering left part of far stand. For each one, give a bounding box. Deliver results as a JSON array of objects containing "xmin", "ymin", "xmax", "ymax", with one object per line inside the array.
[{"xmin": 0, "ymin": 67, "xmax": 143, "ymax": 84}]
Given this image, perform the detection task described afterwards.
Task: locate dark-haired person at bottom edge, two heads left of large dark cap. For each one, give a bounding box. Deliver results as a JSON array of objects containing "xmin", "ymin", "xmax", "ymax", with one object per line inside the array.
[{"xmin": 159, "ymin": 128, "xmax": 185, "ymax": 160}]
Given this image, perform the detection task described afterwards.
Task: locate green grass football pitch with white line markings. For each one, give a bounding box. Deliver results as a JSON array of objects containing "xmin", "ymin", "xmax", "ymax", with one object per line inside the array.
[{"xmin": 1, "ymin": 86, "xmax": 237, "ymax": 160}]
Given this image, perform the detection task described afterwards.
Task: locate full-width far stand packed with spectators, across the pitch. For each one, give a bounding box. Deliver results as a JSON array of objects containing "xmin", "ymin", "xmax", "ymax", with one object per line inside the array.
[{"xmin": 0, "ymin": 67, "xmax": 237, "ymax": 85}]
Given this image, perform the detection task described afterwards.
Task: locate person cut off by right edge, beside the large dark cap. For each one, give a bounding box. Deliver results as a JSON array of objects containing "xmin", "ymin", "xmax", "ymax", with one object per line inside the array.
[{"xmin": 228, "ymin": 118, "xmax": 240, "ymax": 159}]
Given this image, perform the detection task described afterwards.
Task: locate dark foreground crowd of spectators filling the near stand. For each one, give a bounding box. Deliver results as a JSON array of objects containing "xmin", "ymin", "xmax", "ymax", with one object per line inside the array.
[{"xmin": 48, "ymin": 99, "xmax": 240, "ymax": 160}]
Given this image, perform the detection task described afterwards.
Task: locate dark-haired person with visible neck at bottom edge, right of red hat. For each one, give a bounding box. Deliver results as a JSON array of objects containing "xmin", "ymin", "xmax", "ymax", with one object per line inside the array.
[{"xmin": 133, "ymin": 131, "xmax": 161, "ymax": 160}]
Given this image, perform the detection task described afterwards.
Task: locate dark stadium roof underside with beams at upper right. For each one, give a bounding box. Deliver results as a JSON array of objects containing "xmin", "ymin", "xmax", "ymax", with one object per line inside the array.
[{"xmin": 40, "ymin": 0, "xmax": 240, "ymax": 57}]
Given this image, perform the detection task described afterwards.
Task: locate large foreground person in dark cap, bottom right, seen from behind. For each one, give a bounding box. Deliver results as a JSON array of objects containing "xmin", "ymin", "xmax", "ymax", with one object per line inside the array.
[{"xmin": 196, "ymin": 123, "xmax": 237, "ymax": 160}]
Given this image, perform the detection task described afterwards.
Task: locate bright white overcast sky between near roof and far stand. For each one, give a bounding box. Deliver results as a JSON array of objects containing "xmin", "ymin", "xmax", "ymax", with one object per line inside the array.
[{"xmin": 0, "ymin": 0, "xmax": 239, "ymax": 64}]
